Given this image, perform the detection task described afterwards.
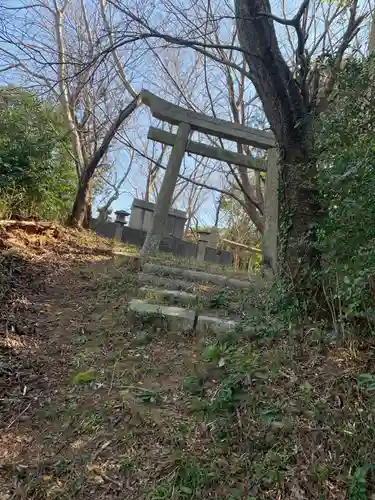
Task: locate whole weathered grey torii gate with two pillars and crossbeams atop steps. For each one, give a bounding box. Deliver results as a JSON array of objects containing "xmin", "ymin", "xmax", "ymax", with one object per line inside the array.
[{"xmin": 138, "ymin": 90, "xmax": 278, "ymax": 272}]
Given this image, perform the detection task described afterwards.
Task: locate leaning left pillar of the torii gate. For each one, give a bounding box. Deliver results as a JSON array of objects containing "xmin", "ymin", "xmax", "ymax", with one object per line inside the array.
[{"xmin": 140, "ymin": 123, "xmax": 191, "ymax": 258}]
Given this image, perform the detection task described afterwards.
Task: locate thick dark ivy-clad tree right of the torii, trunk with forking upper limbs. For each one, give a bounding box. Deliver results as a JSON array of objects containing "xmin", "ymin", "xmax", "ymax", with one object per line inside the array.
[{"xmin": 234, "ymin": 0, "xmax": 362, "ymax": 310}]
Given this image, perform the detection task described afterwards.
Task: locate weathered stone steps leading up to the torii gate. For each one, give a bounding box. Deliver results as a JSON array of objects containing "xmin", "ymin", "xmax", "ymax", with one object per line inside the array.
[{"xmin": 129, "ymin": 263, "xmax": 265, "ymax": 333}]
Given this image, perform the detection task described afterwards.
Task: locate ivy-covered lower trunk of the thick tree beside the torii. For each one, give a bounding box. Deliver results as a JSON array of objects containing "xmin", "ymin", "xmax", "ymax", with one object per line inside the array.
[{"xmin": 279, "ymin": 142, "xmax": 321, "ymax": 304}]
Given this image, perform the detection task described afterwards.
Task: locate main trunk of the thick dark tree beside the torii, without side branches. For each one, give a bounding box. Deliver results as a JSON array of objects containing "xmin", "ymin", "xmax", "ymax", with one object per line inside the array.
[{"xmin": 235, "ymin": 0, "xmax": 320, "ymax": 298}]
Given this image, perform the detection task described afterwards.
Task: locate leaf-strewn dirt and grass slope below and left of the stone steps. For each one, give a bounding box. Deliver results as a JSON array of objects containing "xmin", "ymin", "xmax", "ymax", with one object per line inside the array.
[{"xmin": 0, "ymin": 225, "xmax": 375, "ymax": 500}]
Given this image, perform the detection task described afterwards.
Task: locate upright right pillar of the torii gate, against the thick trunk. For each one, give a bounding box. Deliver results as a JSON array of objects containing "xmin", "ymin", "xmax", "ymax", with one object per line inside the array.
[{"xmin": 262, "ymin": 148, "xmax": 279, "ymax": 279}]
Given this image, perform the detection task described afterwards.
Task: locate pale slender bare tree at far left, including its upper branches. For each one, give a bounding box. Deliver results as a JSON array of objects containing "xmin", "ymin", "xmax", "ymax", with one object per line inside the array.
[{"xmin": 3, "ymin": 0, "xmax": 137, "ymax": 226}]
